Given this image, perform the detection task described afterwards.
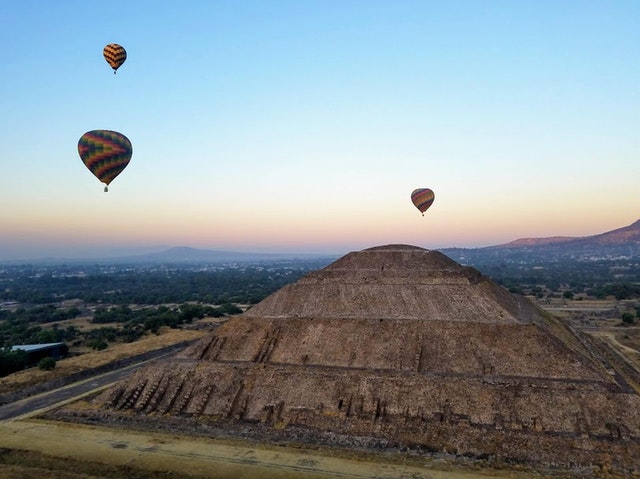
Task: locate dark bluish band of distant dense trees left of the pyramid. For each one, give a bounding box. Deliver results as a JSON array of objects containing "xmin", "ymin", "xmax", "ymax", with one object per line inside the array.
[{"xmin": 0, "ymin": 265, "xmax": 318, "ymax": 305}]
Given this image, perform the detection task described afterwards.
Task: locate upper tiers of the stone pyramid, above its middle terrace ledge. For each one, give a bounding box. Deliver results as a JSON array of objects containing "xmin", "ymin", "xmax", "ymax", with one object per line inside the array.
[{"xmin": 247, "ymin": 245, "xmax": 534, "ymax": 323}]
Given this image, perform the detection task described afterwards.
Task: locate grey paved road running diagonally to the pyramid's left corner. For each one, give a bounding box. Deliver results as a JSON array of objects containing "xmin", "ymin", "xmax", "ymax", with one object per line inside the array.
[{"xmin": 0, "ymin": 353, "xmax": 159, "ymax": 421}]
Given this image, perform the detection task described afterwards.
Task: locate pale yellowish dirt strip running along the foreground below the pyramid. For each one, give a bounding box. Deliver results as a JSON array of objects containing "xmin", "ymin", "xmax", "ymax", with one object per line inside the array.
[{"xmin": 0, "ymin": 420, "xmax": 560, "ymax": 479}]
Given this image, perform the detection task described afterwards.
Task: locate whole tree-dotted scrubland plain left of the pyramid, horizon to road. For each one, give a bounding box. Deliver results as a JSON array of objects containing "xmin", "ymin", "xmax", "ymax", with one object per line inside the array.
[{"xmin": 0, "ymin": 262, "xmax": 316, "ymax": 377}]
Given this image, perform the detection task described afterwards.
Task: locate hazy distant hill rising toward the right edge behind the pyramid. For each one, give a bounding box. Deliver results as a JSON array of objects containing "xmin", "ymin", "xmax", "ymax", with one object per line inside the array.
[{"xmin": 440, "ymin": 220, "xmax": 640, "ymax": 264}]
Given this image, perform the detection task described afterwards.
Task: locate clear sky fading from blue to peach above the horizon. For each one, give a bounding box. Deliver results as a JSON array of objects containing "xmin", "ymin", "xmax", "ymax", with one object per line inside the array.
[{"xmin": 0, "ymin": 0, "xmax": 640, "ymax": 260}]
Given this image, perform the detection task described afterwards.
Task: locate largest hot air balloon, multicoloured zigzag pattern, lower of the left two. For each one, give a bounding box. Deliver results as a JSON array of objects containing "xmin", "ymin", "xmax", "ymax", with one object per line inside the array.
[{"xmin": 78, "ymin": 130, "xmax": 133, "ymax": 191}]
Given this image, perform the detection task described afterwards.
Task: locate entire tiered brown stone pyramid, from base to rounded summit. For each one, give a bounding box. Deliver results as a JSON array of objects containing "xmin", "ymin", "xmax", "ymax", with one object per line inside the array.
[{"xmin": 95, "ymin": 245, "xmax": 640, "ymax": 469}]
